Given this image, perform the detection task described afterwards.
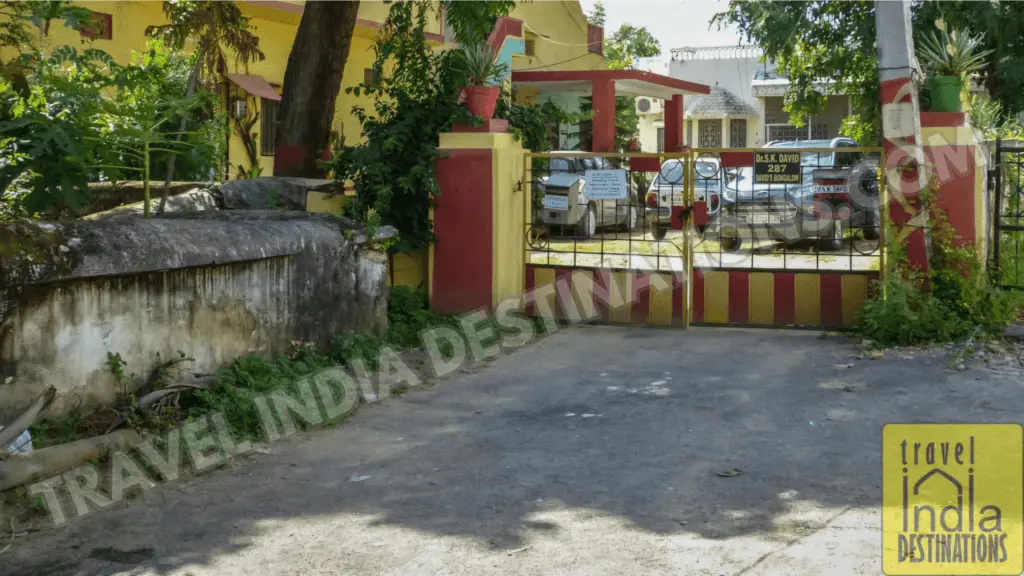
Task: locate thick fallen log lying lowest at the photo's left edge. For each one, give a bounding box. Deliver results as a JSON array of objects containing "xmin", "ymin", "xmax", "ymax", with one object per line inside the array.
[{"xmin": 0, "ymin": 430, "xmax": 142, "ymax": 492}]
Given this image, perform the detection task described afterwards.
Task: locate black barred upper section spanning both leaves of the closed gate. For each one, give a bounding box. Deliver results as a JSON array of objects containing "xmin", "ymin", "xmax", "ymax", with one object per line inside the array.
[{"xmin": 524, "ymin": 142, "xmax": 886, "ymax": 272}]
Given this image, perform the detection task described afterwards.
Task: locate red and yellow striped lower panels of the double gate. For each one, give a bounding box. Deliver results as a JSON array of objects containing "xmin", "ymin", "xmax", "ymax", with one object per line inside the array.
[{"xmin": 525, "ymin": 264, "xmax": 878, "ymax": 328}]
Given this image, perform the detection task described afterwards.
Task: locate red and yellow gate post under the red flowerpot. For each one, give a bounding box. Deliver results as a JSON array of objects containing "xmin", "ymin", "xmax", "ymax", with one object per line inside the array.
[{"xmin": 430, "ymin": 128, "xmax": 528, "ymax": 314}]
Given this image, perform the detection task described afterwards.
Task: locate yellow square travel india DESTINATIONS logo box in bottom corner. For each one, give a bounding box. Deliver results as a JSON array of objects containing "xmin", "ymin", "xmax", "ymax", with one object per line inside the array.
[{"xmin": 882, "ymin": 424, "xmax": 1024, "ymax": 576}]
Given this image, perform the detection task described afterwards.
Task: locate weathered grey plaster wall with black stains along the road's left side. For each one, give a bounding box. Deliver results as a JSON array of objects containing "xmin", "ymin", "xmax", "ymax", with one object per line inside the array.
[{"xmin": 0, "ymin": 210, "xmax": 387, "ymax": 422}]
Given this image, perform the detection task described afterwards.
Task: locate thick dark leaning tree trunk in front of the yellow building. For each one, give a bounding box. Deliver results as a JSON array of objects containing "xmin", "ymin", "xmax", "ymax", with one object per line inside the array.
[{"xmin": 273, "ymin": 2, "xmax": 359, "ymax": 177}]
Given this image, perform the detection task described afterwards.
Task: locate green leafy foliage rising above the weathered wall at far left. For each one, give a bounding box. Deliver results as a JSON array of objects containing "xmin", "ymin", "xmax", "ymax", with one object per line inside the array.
[{"xmin": 0, "ymin": 2, "xmax": 224, "ymax": 214}]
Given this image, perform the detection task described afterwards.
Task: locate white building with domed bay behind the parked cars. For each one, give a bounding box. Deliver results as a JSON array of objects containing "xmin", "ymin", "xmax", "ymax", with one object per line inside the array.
[{"xmin": 637, "ymin": 46, "xmax": 851, "ymax": 152}]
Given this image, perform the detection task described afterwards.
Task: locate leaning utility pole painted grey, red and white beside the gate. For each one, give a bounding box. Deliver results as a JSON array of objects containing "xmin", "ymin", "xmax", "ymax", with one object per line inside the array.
[{"xmin": 874, "ymin": 0, "xmax": 929, "ymax": 273}]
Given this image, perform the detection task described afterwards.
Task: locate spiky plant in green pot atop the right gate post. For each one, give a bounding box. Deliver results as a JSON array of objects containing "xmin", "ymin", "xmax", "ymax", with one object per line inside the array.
[{"xmin": 918, "ymin": 19, "xmax": 992, "ymax": 112}]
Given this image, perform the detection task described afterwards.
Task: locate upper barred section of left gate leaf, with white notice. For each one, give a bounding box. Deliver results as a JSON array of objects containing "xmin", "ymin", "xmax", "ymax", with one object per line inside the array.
[{"xmin": 524, "ymin": 152, "xmax": 692, "ymax": 272}]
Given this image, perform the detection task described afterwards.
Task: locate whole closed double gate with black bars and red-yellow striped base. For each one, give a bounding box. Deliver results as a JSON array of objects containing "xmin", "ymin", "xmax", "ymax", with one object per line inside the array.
[{"xmin": 523, "ymin": 143, "xmax": 887, "ymax": 328}]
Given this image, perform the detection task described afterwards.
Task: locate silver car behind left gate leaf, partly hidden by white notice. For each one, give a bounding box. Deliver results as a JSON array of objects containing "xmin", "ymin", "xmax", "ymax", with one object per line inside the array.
[{"xmin": 534, "ymin": 156, "xmax": 641, "ymax": 238}]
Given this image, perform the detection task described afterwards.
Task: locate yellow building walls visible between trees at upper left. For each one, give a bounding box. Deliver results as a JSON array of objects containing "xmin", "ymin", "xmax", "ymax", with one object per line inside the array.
[{"xmin": 34, "ymin": 0, "xmax": 604, "ymax": 177}]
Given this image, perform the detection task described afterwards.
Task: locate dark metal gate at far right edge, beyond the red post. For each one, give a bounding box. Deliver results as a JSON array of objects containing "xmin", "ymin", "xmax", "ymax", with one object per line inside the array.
[{"xmin": 991, "ymin": 140, "xmax": 1024, "ymax": 289}]
